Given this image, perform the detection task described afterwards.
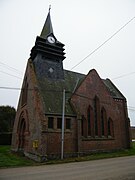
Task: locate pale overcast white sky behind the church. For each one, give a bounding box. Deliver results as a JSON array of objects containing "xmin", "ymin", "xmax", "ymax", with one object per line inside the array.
[{"xmin": 0, "ymin": 0, "xmax": 135, "ymax": 126}]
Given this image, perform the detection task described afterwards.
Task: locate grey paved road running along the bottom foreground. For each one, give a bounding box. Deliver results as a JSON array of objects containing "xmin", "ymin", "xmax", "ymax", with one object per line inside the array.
[{"xmin": 0, "ymin": 156, "xmax": 135, "ymax": 180}]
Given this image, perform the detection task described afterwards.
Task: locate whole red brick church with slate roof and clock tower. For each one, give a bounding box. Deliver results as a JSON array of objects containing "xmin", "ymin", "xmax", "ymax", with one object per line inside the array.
[{"xmin": 12, "ymin": 11, "xmax": 130, "ymax": 161}]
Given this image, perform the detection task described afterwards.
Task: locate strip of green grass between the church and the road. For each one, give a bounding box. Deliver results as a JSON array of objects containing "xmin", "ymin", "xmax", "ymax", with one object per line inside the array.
[{"xmin": 0, "ymin": 142, "xmax": 135, "ymax": 168}]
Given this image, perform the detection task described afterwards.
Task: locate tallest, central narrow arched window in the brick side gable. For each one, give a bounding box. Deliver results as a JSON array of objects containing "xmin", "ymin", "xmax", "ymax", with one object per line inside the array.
[{"xmin": 94, "ymin": 96, "xmax": 100, "ymax": 136}]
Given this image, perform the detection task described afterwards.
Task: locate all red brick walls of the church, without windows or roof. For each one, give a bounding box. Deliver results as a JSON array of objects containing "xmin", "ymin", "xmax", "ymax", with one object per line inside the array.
[{"xmin": 12, "ymin": 64, "xmax": 130, "ymax": 161}]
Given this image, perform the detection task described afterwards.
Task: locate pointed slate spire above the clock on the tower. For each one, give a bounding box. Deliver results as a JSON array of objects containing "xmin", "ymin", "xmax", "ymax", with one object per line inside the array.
[{"xmin": 40, "ymin": 6, "xmax": 53, "ymax": 39}]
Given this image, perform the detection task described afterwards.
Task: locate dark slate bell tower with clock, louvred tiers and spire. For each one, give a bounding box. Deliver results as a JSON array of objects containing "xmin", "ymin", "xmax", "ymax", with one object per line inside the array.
[{"xmin": 30, "ymin": 8, "xmax": 65, "ymax": 80}]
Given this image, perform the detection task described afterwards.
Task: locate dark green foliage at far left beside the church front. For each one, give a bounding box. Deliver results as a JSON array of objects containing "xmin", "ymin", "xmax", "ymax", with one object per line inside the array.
[{"xmin": 0, "ymin": 106, "xmax": 16, "ymax": 133}]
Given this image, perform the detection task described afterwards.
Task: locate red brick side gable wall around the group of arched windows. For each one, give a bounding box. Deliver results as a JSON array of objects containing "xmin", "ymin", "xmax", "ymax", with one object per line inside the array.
[{"xmin": 71, "ymin": 71, "xmax": 130, "ymax": 152}]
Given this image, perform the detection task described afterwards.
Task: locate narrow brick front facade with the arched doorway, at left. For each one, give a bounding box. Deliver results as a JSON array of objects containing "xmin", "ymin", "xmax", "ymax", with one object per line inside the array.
[{"xmin": 12, "ymin": 61, "xmax": 46, "ymax": 159}]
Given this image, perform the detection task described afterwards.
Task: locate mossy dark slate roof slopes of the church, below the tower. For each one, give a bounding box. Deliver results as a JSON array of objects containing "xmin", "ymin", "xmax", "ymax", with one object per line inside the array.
[{"xmin": 35, "ymin": 70, "xmax": 124, "ymax": 116}]
